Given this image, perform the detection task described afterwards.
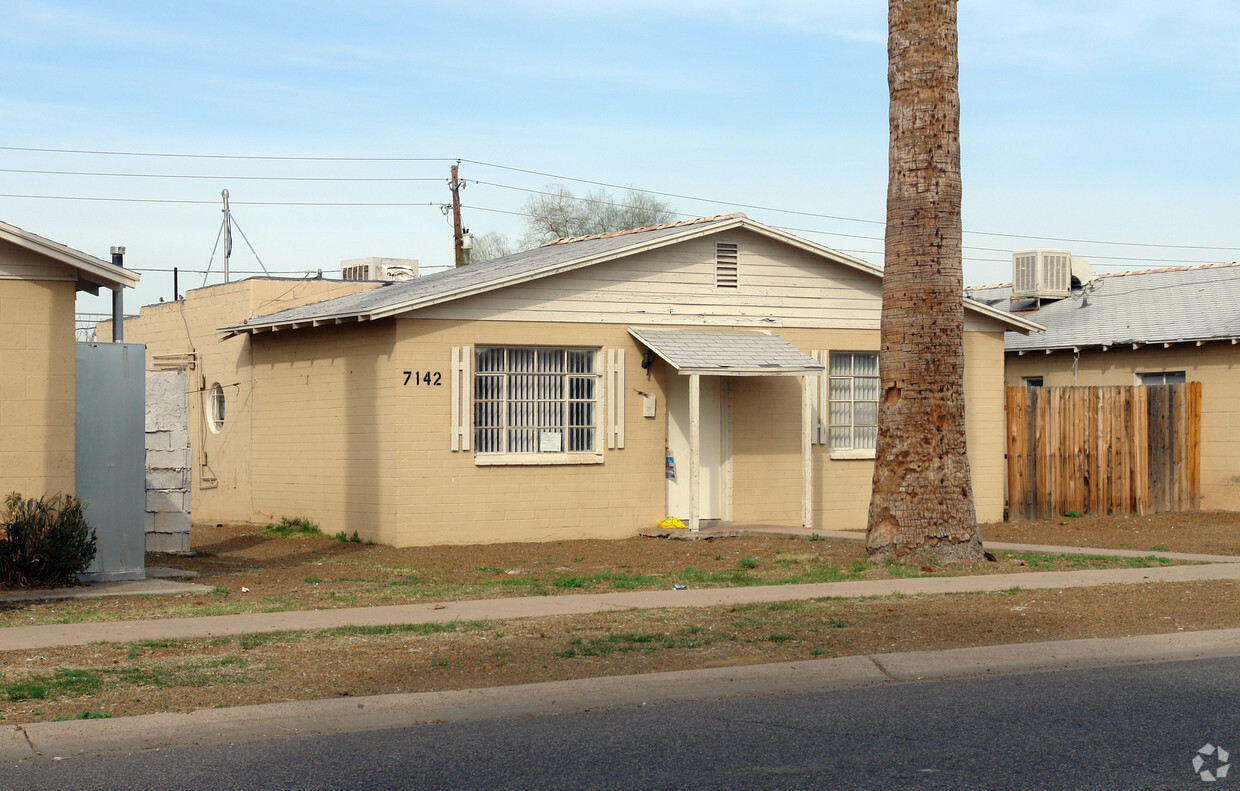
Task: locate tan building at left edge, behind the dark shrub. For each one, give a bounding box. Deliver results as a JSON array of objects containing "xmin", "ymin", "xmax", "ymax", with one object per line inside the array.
[{"xmin": 0, "ymin": 222, "xmax": 139, "ymax": 497}]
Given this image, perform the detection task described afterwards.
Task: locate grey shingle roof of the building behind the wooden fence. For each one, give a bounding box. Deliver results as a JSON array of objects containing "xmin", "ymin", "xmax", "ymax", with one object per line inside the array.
[{"xmin": 967, "ymin": 262, "xmax": 1240, "ymax": 352}]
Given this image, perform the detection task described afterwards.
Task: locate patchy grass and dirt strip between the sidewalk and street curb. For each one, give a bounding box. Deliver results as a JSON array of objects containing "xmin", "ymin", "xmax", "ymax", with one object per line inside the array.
[{"xmin": 0, "ymin": 582, "xmax": 1240, "ymax": 723}]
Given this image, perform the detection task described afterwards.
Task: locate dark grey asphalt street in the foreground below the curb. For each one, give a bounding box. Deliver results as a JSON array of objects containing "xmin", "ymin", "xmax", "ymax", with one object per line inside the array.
[{"xmin": 7, "ymin": 657, "xmax": 1240, "ymax": 791}]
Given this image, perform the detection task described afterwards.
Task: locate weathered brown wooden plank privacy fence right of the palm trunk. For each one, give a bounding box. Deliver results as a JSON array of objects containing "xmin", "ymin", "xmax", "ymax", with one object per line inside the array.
[{"xmin": 1007, "ymin": 382, "xmax": 1202, "ymax": 519}]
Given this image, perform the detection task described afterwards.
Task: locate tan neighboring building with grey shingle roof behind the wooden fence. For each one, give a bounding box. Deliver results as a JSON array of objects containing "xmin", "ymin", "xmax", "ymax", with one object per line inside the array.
[{"xmin": 967, "ymin": 259, "xmax": 1240, "ymax": 510}]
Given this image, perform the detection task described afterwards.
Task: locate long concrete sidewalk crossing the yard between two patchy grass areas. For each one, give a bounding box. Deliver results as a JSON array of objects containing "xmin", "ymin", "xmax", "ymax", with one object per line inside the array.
[{"xmin": 7, "ymin": 563, "xmax": 1240, "ymax": 651}]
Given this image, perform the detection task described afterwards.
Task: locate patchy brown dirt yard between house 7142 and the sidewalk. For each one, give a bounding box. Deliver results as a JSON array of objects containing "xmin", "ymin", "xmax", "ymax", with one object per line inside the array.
[{"xmin": 0, "ymin": 515, "xmax": 1210, "ymax": 627}]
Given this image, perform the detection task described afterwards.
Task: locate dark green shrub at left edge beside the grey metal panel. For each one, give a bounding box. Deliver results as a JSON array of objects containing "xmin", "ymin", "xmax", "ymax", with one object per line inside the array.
[{"xmin": 0, "ymin": 492, "xmax": 97, "ymax": 588}]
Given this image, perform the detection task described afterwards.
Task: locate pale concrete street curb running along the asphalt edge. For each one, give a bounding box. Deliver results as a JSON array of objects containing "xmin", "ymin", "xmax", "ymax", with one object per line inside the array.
[{"xmin": 9, "ymin": 629, "xmax": 1240, "ymax": 764}]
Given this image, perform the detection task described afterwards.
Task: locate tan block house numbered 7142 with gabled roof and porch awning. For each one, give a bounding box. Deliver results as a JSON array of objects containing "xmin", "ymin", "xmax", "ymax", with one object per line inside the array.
[{"xmin": 125, "ymin": 214, "xmax": 1040, "ymax": 546}]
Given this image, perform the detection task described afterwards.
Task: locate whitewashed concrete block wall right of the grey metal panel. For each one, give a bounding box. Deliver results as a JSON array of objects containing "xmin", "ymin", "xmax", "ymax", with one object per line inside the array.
[{"xmin": 145, "ymin": 371, "xmax": 193, "ymax": 554}]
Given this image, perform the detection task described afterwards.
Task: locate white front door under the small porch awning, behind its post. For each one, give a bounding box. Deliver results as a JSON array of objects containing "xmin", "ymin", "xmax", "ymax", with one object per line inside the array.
[{"xmin": 665, "ymin": 373, "xmax": 727, "ymax": 524}]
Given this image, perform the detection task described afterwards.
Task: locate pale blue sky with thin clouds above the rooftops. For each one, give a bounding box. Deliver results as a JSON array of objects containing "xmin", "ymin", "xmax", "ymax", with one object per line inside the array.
[{"xmin": 0, "ymin": 0, "xmax": 1240, "ymax": 311}]
